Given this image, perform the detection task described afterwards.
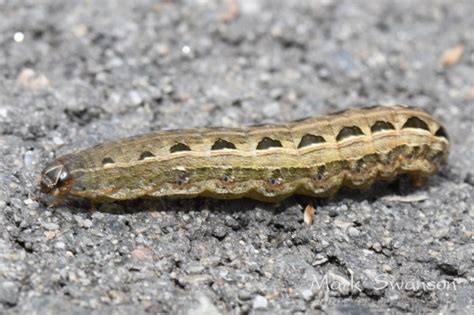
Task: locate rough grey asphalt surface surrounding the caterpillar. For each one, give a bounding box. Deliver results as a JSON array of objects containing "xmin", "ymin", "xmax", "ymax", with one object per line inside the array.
[{"xmin": 0, "ymin": 0, "xmax": 474, "ymax": 314}]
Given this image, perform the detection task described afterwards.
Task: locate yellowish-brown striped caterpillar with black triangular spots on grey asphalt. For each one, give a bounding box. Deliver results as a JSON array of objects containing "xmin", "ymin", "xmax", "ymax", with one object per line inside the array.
[{"xmin": 40, "ymin": 105, "xmax": 449, "ymax": 202}]
